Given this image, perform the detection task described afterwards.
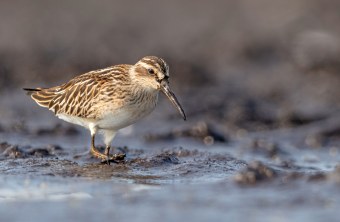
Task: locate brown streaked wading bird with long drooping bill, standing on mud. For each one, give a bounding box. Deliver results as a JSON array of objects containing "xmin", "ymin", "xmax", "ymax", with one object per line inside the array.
[{"xmin": 23, "ymin": 56, "xmax": 186, "ymax": 164}]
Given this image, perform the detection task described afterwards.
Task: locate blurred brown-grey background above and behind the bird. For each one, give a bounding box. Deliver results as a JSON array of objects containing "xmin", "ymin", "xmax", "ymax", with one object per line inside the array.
[{"xmin": 0, "ymin": 0, "xmax": 340, "ymax": 132}]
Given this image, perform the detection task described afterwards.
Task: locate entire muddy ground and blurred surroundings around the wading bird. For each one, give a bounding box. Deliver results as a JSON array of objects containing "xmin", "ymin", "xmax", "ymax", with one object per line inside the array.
[{"xmin": 0, "ymin": 0, "xmax": 340, "ymax": 222}]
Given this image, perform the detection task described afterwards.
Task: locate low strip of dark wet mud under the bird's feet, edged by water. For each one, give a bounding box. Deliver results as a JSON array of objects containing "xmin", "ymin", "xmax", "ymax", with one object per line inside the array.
[{"xmin": 0, "ymin": 143, "xmax": 246, "ymax": 184}]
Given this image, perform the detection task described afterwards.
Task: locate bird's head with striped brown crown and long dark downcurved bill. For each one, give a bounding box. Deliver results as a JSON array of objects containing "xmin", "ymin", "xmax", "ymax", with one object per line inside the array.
[{"xmin": 133, "ymin": 56, "xmax": 186, "ymax": 120}]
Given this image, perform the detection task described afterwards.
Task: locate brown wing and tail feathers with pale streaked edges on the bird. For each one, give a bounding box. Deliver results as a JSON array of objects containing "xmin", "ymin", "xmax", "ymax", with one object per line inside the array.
[{"xmin": 24, "ymin": 65, "xmax": 129, "ymax": 118}]
